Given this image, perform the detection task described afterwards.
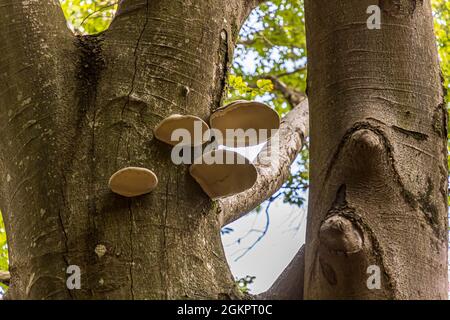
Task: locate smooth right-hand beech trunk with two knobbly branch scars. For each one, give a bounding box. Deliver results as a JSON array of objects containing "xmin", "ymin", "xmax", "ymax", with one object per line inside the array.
[{"xmin": 304, "ymin": 0, "xmax": 448, "ymax": 299}]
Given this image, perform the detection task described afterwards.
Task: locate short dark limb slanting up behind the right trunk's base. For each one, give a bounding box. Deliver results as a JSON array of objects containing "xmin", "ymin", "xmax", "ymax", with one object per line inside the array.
[{"xmin": 256, "ymin": 245, "xmax": 305, "ymax": 300}]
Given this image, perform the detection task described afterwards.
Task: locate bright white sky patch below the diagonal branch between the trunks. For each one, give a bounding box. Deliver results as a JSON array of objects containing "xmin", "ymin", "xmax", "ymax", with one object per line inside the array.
[{"xmin": 222, "ymin": 198, "xmax": 306, "ymax": 294}]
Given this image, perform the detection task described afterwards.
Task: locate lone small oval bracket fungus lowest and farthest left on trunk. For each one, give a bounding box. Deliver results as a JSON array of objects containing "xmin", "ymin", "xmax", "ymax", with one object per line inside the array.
[{"xmin": 109, "ymin": 167, "xmax": 158, "ymax": 197}]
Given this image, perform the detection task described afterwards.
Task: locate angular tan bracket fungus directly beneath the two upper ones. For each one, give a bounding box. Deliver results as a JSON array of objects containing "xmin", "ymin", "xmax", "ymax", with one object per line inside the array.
[{"xmin": 189, "ymin": 149, "xmax": 258, "ymax": 199}]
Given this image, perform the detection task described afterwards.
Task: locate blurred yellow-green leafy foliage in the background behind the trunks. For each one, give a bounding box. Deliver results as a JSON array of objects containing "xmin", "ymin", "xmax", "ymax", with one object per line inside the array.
[{"xmin": 0, "ymin": 0, "xmax": 450, "ymax": 291}]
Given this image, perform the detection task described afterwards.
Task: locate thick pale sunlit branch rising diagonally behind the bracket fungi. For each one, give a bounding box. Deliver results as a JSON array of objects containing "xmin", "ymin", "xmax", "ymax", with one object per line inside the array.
[{"xmin": 219, "ymin": 99, "xmax": 309, "ymax": 225}]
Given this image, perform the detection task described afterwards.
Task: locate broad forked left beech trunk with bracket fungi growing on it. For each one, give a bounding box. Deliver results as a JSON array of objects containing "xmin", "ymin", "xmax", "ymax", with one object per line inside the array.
[{"xmin": 0, "ymin": 0, "xmax": 264, "ymax": 299}]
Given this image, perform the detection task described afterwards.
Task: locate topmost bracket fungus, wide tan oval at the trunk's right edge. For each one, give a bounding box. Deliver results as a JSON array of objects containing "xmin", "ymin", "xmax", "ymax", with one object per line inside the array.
[{"xmin": 209, "ymin": 100, "xmax": 280, "ymax": 147}]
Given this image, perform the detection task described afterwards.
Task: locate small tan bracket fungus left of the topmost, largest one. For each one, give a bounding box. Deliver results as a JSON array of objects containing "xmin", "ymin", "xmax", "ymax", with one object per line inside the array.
[{"xmin": 154, "ymin": 114, "xmax": 209, "ymax": 146}]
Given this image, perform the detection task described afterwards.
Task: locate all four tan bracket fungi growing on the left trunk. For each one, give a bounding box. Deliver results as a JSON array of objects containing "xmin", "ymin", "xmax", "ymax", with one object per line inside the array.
[{"xmin": 109, "ymin": 100, "xmax": 280, "ymax": 199}]
